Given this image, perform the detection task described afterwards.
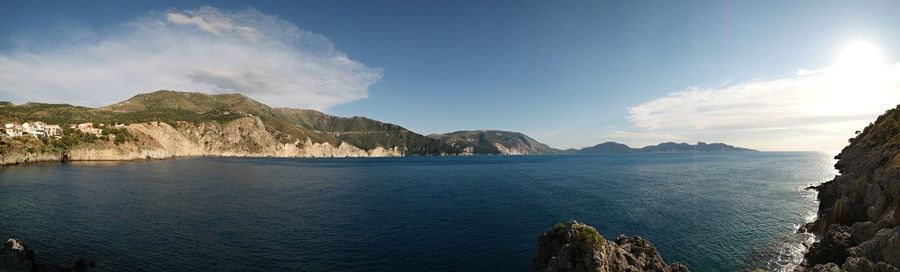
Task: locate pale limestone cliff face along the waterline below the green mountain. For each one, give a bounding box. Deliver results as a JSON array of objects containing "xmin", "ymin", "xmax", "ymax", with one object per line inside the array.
[{"xmin": 0, "ymin": 116, "xmax": 405, "ymax": 165}]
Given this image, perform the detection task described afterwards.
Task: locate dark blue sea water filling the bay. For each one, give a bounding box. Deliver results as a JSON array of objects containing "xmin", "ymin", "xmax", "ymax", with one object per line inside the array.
[{"xmin": 0, "ymin": 152, "xmax": 835, "ymax": 271}]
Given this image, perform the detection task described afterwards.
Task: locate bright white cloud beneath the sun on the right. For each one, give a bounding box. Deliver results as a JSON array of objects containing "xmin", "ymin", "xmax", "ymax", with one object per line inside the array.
[{"xmin": 628, "ymin": 64, "xmax": 900, "ymax": 150}]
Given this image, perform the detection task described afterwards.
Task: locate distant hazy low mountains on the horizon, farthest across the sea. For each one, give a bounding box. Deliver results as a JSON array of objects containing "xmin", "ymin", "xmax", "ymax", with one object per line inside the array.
[{"xmin": 569, "ymin": 142, "xmax": 756, "ymax": 153}]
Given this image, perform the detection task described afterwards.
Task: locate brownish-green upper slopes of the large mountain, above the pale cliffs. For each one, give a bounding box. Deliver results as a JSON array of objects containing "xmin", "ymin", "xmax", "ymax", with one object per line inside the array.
[{"xmin": 103, "ymin": 91, "xmax": 459, "ymax": 155}]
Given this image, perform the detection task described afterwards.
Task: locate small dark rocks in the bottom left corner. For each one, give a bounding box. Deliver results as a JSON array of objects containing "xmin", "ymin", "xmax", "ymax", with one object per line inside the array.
[{"xmin": 0, "ymin": 239, "xmax": 94, "ymax": 272}]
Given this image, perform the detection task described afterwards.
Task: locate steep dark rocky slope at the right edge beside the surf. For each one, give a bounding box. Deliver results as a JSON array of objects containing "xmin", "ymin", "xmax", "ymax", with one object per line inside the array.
[{"xmin": 798, "ymin": 107, "xmax": 900, "ymax": 271}]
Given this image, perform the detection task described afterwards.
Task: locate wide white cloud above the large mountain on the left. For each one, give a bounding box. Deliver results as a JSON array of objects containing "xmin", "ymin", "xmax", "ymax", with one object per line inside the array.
[{"xmin": 0, "ymin": 7, "xmax": 382, "ymax": 109}]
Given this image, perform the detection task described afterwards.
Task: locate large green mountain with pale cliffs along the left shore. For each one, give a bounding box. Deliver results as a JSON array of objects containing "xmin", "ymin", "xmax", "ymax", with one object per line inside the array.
[{"xmin": 0, "ymin": 90, "xmax": 462, "ymax": 164}]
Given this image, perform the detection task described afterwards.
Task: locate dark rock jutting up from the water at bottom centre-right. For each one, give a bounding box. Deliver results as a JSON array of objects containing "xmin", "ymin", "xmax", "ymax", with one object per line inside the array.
[{"xmin": 531, "ymin": 221, "xmax": 690, "ymax": 272}]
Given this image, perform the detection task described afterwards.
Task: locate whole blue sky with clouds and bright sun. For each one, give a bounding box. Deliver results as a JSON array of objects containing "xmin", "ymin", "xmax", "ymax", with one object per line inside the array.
[{"xmin": 0, "ymin": 0, "xmax": 900, "ymax": 152}]
